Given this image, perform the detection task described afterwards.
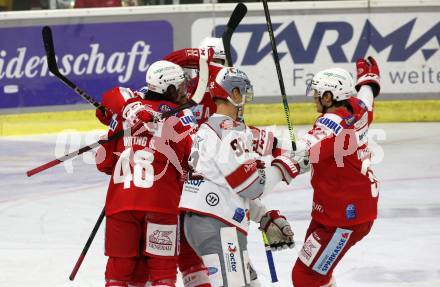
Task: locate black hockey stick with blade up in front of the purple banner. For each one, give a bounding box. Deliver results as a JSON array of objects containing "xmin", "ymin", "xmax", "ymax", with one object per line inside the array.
[{"xmin": 42, "ymin": 26, "xmax": 105, "ymax": 112}]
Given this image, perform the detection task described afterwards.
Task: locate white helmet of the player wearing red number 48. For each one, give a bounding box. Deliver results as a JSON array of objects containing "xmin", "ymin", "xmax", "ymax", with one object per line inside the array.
[{"xmin": 145, "ymin": 60, "xmax": 186, "ymax": 94}]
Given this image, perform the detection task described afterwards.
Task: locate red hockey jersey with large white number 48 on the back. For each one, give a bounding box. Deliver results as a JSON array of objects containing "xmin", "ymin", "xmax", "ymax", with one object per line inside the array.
[{"xmin": 96, "ymin": 100, "xmax": 195, "ymax": 215}]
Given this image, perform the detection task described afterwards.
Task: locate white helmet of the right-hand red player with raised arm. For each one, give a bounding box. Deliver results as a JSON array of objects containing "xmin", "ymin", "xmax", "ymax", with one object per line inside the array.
[{"xmin": 306, "ymin": 68, "xmax": 356, "ymax": 101}]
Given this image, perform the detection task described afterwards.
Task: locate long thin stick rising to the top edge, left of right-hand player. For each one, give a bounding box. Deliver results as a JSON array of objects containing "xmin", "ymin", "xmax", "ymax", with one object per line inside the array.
[{"xmin": 263, "ymin": 0, "xmax": 296, "ymax": 151}]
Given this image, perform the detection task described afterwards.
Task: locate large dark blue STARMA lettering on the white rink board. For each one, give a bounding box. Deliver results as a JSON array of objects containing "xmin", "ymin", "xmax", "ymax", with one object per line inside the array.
[{"xmin": 215, "ymin": 18, "xmax": 440, "ymax": 66}]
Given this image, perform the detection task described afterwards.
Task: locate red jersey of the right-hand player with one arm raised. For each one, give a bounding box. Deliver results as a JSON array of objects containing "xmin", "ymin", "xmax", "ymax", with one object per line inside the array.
[{"xmin": 297, "ymin": 98, "xmax": 379, "ymax": 226}]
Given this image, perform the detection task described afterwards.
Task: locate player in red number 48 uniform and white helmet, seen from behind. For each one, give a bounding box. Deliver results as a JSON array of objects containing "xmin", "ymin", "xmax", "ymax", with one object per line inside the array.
[{"xmin": 97, "ymin": 61, "xmax": 199, "ymax": 287}]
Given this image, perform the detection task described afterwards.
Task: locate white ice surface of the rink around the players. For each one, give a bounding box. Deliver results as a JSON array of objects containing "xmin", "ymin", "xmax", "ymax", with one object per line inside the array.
[{"xmin": 0, "ymin": 123, "xmax": 440, "ymax": 287}]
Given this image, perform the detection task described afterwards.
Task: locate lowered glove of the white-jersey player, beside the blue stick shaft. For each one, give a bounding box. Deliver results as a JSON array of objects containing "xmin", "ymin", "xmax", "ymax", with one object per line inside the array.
[{"xmin": 259, "ymin": 210, "xmax": 295, "ymax": 251}]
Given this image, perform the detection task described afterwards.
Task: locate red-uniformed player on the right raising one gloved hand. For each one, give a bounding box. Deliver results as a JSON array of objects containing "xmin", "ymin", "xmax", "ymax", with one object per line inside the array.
[{"xmin": 292, "ymin": 57, "xmax": 380, "ymax": 287}]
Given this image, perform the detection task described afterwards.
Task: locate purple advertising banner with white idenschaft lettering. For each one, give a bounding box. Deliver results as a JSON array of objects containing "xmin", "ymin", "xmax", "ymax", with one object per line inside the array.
[{"xmin": 0, "ymin": 20, "xmax": 173, "ymax": 109}]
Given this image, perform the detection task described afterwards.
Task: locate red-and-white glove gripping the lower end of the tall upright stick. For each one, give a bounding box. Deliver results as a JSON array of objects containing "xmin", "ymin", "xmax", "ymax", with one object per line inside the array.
[{"xmin": 271, "ymin": 153, "xmax": 310, "ymax": 184}]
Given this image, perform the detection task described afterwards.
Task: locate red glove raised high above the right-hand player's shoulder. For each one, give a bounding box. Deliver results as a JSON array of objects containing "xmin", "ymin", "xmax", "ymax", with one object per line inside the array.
[{"xmin": 355, "ymin": 57, "xmax": 380, "ymax": 97}]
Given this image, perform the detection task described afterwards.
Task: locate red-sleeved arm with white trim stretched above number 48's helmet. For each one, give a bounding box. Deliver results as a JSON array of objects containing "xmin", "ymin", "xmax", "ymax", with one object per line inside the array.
[{"xmin": 163, "ymin": 48, "xmax": 214, "ymax": 69}]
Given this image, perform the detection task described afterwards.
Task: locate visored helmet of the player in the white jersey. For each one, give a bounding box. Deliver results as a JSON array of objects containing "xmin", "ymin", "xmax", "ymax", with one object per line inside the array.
[{"xmin": 209, "ymin": 67, "xmax": 254, "ymax": 107}]
